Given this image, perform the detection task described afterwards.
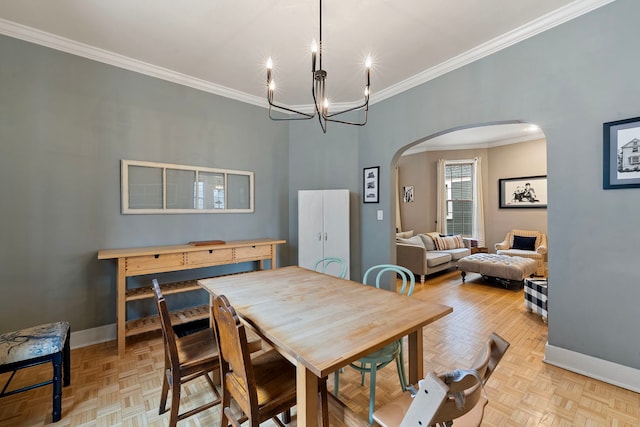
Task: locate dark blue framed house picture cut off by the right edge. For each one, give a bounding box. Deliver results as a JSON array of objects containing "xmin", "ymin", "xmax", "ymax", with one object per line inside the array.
[{"xmin": 602, "ymin": 117, "xmax": 640, "ymax": 190}]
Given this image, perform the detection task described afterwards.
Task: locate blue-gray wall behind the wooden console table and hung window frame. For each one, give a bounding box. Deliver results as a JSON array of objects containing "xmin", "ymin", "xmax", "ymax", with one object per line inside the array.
[{"xmin": 0, "ymin": 37, "xmax": 289, "ymax": 331}]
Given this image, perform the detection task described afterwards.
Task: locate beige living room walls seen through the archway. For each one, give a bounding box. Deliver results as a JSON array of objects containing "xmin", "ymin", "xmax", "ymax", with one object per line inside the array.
[{"xmin": 397, "ymin": 139, "xmax": 547, "ymax": 252}]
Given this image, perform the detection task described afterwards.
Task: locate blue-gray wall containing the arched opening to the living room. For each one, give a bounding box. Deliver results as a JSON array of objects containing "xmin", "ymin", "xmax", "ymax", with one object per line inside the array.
[{"xmin": 358, "ymin": 0, "xmax": 640, "ymax": 369}]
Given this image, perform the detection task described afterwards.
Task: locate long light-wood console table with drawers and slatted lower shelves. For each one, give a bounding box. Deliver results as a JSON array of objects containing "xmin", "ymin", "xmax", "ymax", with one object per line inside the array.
[{"xmin": 98, "ymin": 239, "xmax": 286, "ymax": 356}]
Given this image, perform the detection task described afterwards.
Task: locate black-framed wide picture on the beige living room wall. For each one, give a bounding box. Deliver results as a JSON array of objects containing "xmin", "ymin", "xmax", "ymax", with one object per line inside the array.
[{"xmin": 498, "ymin": 175, "xmax": 547, "ymax": 209}]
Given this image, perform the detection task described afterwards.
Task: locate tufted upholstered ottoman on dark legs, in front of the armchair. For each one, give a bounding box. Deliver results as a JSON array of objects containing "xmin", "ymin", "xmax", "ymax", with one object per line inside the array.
[{"xmin": 458, "ymin": 253, "xmax": 538, "ymax": 287}]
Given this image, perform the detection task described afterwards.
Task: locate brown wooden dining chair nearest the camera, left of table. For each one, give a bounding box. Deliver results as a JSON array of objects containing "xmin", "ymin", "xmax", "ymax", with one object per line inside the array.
[{"xmin": 212, "ymin": 295, "xmax": 329, "ymax": 427}]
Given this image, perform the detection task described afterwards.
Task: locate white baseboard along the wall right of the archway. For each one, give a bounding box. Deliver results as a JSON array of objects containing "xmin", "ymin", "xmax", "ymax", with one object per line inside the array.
[{"xmin": 544, "ymin": 343, "xmax": 640, "ymax": 393}]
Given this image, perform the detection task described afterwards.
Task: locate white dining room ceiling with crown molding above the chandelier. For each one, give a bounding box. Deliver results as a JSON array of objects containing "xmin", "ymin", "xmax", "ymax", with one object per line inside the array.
[{"xmin": 0, "ymin": 0, "xmax": 613, "ymax": 145}]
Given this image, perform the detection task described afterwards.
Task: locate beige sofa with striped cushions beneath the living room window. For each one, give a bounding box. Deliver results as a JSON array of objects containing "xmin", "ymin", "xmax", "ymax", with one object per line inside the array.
[{"xmin": 396, "ymin": 231, "xmax": 471, "ymax": 283}]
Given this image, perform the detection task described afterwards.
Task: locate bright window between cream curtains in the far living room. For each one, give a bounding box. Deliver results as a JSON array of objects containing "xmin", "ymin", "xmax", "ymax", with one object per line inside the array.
[{"xmin": 445, "ymin": 162, "xmax": 475, "ymax": 237}]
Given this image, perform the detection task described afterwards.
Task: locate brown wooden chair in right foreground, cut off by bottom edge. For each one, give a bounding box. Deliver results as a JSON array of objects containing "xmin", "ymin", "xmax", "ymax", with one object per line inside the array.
[{"xmin": 373, "ymin": 332, "xmax": 509, "ymax": 427}]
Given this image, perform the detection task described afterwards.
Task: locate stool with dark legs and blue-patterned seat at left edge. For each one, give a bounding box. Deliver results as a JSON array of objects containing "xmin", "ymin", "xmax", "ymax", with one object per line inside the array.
[{"xmin": 0, "ymin": 322, "xmax": 71, "ymax": 422}]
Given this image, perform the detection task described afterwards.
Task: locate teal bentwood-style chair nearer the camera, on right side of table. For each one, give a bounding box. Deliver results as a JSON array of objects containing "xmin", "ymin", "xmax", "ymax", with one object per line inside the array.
[{"xmin": 333, "ymin": 264, "xmax": 415, "ymax": 424}]
